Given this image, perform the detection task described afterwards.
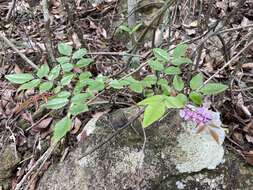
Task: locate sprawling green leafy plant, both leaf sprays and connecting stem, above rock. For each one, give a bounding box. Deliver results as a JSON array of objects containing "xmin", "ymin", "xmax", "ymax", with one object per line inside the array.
[{"xmin": 5, "ymin": 43, "xmax": 227, "ymax": 143}]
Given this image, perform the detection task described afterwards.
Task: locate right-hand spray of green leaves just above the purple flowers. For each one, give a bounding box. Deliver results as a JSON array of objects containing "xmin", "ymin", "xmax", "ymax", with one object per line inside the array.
[{"xmin": 138, "ymin": 44, "xmax": 227, "ymax": 127}]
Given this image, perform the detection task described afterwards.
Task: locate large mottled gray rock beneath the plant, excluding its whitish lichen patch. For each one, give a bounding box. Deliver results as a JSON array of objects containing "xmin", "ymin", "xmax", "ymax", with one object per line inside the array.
[{"xmin": 38, "ymin": 109, "xmax": 253, "ymax": 190}]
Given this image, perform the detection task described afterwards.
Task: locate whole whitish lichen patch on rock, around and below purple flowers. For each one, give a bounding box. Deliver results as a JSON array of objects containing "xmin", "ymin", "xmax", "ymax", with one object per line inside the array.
[{"xmin": 175, "ymin": 106, "xmax": 225, "ymax": 173}]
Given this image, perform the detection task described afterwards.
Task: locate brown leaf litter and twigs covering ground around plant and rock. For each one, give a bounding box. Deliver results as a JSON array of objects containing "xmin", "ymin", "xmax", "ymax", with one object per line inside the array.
[{"xmin": 0, "ymin": 0, "xmax": 253, "ymax": 189}]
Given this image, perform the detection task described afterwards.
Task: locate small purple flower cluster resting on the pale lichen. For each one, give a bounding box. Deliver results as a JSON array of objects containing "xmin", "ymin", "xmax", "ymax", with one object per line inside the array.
[{"xmin": 179, "ymin": 106, "xmax": 212, "ymax": 124}]
